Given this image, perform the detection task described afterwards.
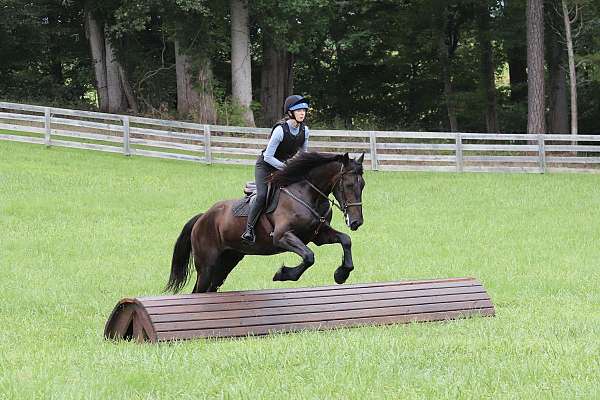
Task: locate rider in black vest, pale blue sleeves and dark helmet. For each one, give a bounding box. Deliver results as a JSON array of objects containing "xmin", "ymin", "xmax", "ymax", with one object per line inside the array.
[{"xmin": 242, "ymin": 95, "xmax": 308, "ymax": 243}]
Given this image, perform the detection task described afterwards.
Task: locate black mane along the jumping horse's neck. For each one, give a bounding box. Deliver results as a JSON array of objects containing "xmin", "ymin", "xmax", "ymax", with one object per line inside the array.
[{"xmin": 269, "ymin": 152, "xmax": 344, "ymax": 187}]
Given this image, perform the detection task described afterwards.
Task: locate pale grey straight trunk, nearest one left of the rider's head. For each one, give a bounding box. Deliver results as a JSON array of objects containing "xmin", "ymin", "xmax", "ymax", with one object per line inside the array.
[{"xmin": 231, "ymin": 0, "xmax": 254, "ymax": 126}]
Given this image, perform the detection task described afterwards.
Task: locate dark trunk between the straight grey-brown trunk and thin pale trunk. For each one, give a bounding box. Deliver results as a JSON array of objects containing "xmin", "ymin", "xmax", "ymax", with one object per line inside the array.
[{"xmin": 547, "ymin": 18, "xmax": 569, "ymax": 134}]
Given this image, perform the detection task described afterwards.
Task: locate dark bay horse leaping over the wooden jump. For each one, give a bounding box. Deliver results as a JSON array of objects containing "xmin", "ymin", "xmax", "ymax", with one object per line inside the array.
[{"xmin": 166, "ymin": 152, "xmax": 365, "ymax": 293}]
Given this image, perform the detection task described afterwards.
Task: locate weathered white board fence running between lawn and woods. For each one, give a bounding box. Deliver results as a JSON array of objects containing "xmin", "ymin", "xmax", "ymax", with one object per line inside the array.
[{"xmin": 0, "ymin": 102, "xmax": 600, "ymax": 173}]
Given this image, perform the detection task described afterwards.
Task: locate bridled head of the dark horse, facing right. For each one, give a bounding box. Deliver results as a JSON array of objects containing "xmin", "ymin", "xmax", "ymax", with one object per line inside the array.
[{"xmin": 333, "ymin": 153, "xmax": 365, "ymax": 231}]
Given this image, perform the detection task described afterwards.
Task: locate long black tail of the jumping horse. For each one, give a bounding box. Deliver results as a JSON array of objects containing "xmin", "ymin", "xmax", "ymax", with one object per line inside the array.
[{"xmin": 165, "ymin": 214, "xmax": 202, "ymax": 293}]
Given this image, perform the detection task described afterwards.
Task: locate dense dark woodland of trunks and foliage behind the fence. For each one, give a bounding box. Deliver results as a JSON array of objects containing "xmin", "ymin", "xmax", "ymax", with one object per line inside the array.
[{"xmin": 0, "ymin": 0, "xmax": 600, "ymax": 133}]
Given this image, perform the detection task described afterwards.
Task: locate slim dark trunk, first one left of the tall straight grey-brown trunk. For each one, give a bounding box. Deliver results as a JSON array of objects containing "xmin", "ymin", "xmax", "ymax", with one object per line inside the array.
[{"xmin": 477, "ymin": 3, "xmax": 498, "ymax": 132}]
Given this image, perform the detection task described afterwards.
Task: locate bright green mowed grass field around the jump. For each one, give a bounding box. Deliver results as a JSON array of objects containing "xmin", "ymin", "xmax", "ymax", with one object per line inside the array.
[{"xmin": 0, "ymin": 142, "xmax": 600, "ymax": 400}]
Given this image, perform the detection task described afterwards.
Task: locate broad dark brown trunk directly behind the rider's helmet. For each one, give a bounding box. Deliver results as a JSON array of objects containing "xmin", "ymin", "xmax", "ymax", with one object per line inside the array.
[{"xmin": 260, "ymin": 32, "xmax": 293, "ymax": 126}]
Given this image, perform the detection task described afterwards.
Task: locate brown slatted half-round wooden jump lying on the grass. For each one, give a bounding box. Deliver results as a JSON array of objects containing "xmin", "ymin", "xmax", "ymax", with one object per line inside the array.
[{"xmin": 104, "ymin": 278, "xmax": 494, "ymax": 342}]
